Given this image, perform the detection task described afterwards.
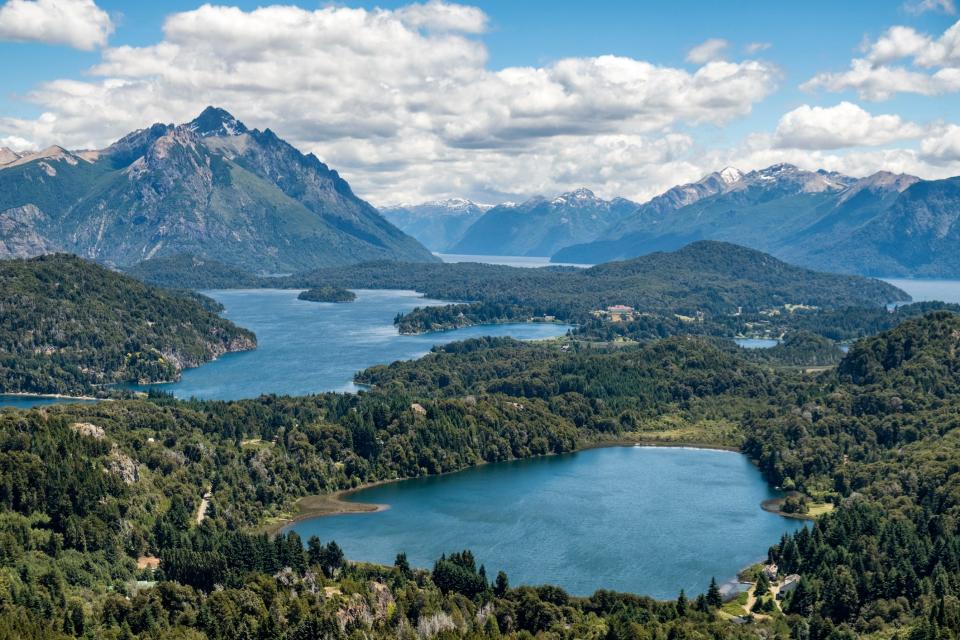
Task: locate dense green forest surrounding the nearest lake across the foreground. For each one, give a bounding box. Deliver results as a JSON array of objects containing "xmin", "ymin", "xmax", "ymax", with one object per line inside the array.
[{"xmin": 0, "ymin": 311, "xmax": 960, "ymax": 640}]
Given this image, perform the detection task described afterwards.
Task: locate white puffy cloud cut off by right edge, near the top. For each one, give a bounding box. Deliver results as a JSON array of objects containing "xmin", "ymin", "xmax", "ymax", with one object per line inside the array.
[{"xmin": 801, "ymin": 21, "xmax": 960, "ymax": 100}]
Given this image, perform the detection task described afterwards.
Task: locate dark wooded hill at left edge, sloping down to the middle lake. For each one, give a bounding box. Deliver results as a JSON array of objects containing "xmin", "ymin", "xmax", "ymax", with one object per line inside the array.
[{"xmin": 0, "ymin": 254, "xmax": 256, "ymax": 393}]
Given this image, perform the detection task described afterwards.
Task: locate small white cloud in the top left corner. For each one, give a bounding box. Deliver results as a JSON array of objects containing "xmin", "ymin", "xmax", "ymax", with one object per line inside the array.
[{"xmin": 0, "ymin": 0, "xmax": 113, "ymax": 50}]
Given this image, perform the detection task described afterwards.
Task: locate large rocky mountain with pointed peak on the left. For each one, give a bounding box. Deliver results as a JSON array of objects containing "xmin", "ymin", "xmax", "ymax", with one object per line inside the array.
[{"xmin": 0, "ymin": 107, "xmax": 435, "ymax": 273}]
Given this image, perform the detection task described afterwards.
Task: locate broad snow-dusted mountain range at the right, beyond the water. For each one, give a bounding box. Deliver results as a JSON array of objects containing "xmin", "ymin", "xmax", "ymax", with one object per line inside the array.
[{"xmin": 552, "ymin": 164, "xmax": 960, "ymax": 277}]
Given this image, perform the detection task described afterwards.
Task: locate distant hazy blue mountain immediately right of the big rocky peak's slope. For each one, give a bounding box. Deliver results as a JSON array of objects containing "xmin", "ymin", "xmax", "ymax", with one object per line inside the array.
[{"xmin": 380, "ymin": 198, "xmax": 492, "ymax": 251}]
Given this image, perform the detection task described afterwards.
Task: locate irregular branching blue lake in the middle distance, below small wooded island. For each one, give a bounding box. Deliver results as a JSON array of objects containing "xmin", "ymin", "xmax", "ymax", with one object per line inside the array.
[{"xmin": 135, "ymin": 289, "xmax": 571, "ymax": 400}]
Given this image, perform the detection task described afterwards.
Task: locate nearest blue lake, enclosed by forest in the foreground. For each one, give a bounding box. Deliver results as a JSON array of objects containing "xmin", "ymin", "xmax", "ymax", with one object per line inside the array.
[{"xmin": 290, "ymin": 447, "xmax": 804, "ymax": 598}]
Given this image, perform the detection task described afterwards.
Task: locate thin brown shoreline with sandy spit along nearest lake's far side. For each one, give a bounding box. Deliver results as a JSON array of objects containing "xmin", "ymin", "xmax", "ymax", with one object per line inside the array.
[{"xmin": 258, "ymin": 438, "xmax": 752, "ymax": 536}]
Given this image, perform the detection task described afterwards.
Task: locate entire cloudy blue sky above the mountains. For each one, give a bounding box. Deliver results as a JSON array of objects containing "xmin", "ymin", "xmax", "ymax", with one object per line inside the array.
[{"xmin": 0, "ymin": 0, "xmax": 960, "ymax": 205}]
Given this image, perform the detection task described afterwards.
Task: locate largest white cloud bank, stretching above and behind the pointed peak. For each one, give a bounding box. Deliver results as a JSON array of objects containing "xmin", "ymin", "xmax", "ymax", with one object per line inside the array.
[{"xmin": 0, "ymin": 1, "xmax": 779, "ymax": 202}]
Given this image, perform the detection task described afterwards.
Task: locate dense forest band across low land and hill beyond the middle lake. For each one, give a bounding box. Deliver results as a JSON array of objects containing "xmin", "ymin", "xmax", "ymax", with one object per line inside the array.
[{"xmin": 122, "ymin": 241, "xmax": 910, "ymax": 348}]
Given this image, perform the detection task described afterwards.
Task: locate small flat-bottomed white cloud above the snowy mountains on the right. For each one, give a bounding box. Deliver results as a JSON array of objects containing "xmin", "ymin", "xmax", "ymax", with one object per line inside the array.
[{"xmin": 774, "ymin": 102, "xmax": 924, "ymax": 149}]
